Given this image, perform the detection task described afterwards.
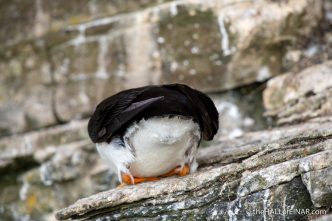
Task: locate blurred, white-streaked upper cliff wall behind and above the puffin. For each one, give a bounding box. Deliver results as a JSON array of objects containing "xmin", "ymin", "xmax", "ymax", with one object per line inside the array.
[{"xmin": 0, "ymin": 0, "xmax": 324, "ymax": 136}]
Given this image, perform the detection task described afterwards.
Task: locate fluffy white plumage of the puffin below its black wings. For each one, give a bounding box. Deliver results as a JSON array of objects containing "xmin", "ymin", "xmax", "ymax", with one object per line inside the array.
[{"xmin": 97, "ymin": 116, "xmax": 201, "ymax": 181}]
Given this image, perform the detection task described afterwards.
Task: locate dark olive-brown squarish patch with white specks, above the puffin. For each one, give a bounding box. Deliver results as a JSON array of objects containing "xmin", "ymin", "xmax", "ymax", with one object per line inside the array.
[{"xmin": 156, "ymin": 5, "xmax": 233, "ymax": 90}]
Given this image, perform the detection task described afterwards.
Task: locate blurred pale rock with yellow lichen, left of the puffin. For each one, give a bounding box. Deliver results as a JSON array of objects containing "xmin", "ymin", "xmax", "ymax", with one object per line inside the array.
[{"xmin": 0, "ymin": 121, "xmax": 118, "ymax": 221}]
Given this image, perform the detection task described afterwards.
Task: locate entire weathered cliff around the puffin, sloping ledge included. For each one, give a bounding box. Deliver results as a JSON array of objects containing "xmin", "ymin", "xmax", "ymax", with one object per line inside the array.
[{"xmin": 0, "ymin": 0, "xmax": 332, "ymax": 221}]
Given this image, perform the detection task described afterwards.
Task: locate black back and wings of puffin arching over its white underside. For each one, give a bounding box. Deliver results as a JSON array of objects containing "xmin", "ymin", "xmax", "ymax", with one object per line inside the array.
[{"xmin": 88, "ymin": 84, "xmax": 219, "ymax": 143}]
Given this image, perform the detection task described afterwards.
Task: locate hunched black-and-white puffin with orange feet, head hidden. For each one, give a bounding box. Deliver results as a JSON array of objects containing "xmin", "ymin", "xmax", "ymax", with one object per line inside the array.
[{"xmin": 88, "ymin": 84, "xmax": 219, "ymax": 186}]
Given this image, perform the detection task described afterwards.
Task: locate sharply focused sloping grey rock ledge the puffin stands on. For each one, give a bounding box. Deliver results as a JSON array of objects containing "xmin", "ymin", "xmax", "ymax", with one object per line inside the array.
[{"xmin": 56, "ymin": 118, "xmax": 332, "ymax": 220}]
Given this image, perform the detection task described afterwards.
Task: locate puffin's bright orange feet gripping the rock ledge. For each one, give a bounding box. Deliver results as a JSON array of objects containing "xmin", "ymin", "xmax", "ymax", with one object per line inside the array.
[{"xmin": 118, "ymin": 164, "xmax": 190, "ymax": 185}]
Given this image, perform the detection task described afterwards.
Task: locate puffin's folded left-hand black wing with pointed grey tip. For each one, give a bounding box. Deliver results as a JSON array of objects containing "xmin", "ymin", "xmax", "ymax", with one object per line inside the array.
[{"xmin": 88, "ymin": 87, "xmax": 163, "ymax": 143}]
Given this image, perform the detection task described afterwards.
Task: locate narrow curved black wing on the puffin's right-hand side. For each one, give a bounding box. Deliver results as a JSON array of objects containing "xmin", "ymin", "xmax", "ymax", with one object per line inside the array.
[{"xmin": 164, "ymin": 84, "xmax": 219, "ymax": 140}]
